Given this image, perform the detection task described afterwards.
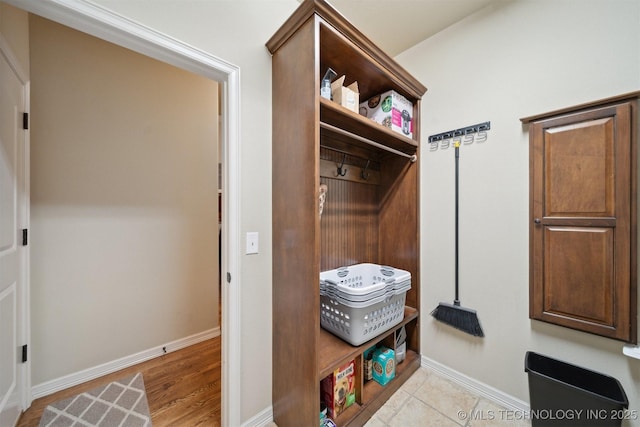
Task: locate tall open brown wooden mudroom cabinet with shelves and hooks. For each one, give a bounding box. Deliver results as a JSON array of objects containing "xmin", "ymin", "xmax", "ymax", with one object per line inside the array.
[{"xmin": 266, "ymin": 0, "xmax": 426, "ymax": 427}]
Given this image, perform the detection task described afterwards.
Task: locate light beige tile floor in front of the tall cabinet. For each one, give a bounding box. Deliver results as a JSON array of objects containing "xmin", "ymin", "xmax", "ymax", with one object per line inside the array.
[{"xmin": 365, "ymin": 368, "xmax": 531, "ymax": 427}]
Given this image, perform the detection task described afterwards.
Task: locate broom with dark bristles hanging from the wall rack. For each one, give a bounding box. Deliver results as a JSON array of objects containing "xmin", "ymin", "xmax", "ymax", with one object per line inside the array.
[{"xmin": 431, "ymin": 141, "xmax": 484, "ymax": 337}]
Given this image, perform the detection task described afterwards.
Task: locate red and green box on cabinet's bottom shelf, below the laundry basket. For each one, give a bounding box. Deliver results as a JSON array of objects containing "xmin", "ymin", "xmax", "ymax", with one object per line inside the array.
[{"xmin": 320, "ymin": 360, "xmax": 356, "ymax": 418}]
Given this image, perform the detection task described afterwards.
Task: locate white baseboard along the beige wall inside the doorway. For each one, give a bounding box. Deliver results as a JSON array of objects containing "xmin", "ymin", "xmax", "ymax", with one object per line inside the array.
[{"xmin": 31, "ymin": 327, "xmax": 220, "ymax": 400}]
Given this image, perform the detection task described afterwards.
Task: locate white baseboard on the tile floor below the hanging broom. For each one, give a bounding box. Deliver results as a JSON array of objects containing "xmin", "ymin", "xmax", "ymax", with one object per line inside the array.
[{"xmin": 421, "ymin": 356, "xmax": 530, "ymax": 412}]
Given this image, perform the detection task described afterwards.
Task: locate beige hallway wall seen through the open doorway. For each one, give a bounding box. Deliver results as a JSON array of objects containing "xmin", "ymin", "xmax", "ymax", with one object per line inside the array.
[{"xmin": 29, "ymin": 16, "xmax": 219, "ymax": 385}]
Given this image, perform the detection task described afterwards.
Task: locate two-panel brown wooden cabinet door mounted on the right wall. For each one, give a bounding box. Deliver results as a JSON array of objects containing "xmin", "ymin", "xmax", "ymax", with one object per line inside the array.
[{"xmin": 529, "ymin": 102, "xmax": 637, "ymax": 342}]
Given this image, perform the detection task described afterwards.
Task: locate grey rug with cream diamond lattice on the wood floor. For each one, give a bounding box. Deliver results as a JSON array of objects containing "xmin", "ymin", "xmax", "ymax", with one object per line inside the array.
[{"xmin": 39, "ymin": 373, "xmax": 151, "ymax": 427}]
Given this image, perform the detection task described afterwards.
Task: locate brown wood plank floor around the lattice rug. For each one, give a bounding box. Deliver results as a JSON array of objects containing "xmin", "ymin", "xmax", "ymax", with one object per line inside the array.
[{"xmin": 18, "ymin": 337, "xmax": 222, "ymax": 427}]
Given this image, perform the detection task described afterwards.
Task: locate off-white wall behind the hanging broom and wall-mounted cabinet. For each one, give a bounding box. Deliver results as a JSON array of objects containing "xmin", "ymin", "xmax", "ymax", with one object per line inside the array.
[{"xmin": 397, "ymin": 0, "xmax": 640, "ymax": 426}]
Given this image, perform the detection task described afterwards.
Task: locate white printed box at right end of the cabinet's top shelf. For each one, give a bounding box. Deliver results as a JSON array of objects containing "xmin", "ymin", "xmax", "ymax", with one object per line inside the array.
[{"xmin": 359, "ymin": 90, "xmax": 413, "ymax": 138}]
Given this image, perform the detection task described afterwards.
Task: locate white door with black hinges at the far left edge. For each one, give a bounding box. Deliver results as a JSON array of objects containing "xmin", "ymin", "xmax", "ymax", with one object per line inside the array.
[{"xmin": 0, "ymin": 39, "xmax": 28, "ymax": 426}]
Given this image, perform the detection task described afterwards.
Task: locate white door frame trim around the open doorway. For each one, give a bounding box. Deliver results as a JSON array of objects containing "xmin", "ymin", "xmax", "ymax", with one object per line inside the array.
[{"xmin": 6, "ymin": 0, "xmax": 241, "ymax": 425}]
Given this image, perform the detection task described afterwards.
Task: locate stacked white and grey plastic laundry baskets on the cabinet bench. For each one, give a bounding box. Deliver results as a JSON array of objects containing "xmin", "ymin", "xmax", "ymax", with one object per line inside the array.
[{"xmin": 320, "ymin": 263, "xmax": 411, "ymax": 345}]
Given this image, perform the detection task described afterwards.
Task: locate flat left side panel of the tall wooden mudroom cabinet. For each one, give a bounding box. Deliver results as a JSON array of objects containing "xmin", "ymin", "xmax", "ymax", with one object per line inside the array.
[{"xmin": 272, "ymin": 13, "xmax": 320, "ymax": 426}]
